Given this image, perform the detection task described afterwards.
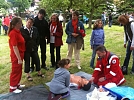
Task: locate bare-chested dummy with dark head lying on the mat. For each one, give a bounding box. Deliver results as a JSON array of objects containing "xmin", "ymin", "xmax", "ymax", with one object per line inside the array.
[{"xmin": 70, "ymin": 74, "xmax": 91, "ymax": 91}]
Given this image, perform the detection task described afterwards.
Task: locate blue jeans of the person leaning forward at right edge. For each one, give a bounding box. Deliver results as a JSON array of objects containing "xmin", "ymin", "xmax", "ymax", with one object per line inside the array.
[{"xmin": 123, "ymin": 41, "xmax": 134, "ymax": 72}]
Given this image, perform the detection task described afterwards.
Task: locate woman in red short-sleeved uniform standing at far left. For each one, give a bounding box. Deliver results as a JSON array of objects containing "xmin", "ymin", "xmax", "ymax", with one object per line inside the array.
[{"xmin": 8, "ymin": 17, "xmax": 25, "ymax": 92}]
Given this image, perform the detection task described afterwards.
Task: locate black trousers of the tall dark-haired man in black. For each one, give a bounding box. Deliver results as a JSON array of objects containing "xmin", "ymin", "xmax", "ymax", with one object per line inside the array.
[{"xmin": 40, "ymin": 38, "xmax": 46, "ymax": 67}]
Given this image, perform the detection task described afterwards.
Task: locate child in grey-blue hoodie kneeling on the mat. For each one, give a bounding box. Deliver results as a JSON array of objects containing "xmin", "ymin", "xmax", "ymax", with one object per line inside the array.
[{"xmin": 49, "ymin": 59, "xmax": 70, "ymax": 100}]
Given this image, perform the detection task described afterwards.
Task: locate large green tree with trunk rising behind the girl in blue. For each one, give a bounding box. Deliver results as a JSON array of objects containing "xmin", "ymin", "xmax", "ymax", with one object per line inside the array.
[{"xmin": 40, "ymin": 0, "xmax": 113, "ymax": 28}]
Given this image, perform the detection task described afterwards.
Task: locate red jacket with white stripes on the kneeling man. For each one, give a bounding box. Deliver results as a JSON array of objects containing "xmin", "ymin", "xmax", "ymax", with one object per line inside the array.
[{"xmin": 93, "ymin": 51, "xmax": 125, "ymax": 85}]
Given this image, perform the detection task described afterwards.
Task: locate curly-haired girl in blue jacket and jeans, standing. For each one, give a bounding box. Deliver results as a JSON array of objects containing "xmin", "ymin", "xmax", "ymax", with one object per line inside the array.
[{"xmin": 90, "ymin": 19, "xmax": 105, "ymax": 68}]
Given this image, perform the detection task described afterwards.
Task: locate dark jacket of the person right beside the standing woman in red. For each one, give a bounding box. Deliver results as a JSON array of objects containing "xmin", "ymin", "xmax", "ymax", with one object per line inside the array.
[{"xmin": 20, "ymin": 27, "xmax": 39, "ymax": 52}]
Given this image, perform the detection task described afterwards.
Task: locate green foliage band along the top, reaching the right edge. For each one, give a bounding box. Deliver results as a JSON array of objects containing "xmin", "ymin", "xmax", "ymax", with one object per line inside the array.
[{"xmin": 40, "ymin": 0, "xmax": 134, "ymax": 28}]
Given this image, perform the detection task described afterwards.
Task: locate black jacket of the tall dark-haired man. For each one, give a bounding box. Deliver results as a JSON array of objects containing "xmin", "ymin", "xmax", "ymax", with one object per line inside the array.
[{"xmin": 33, "ymin": 16, "xmax": 50, "ymax": 39}]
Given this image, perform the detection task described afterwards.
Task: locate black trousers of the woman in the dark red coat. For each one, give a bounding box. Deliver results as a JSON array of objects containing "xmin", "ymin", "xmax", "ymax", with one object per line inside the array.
[{"xmin": 50, "ymin": 43, "xmax": 61, "ymax": 68}]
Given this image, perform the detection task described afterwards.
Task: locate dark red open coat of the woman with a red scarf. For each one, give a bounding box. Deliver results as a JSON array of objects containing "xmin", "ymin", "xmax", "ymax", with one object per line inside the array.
[{"xmin": 49, "ymin": 22, "xmax": 63, "ymax": 46}]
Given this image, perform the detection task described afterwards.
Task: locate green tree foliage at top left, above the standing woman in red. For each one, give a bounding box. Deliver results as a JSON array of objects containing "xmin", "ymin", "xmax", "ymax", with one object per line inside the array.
[{"xmin": 7, "ymin": 0, "xmax": 32, "ymax": 15}]
